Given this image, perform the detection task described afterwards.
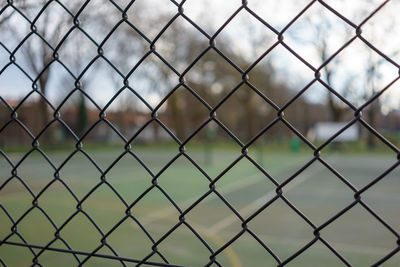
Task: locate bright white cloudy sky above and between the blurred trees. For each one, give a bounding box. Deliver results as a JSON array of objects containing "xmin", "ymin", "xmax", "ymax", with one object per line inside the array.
[{"xmin": 0, "ymin": 0, "xmax": 400, "ymax": 112}]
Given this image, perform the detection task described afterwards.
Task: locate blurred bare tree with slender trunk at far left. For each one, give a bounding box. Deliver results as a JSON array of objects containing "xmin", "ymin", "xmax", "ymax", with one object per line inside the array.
[{"xmin": 1, "ymin": 0, "xmax": 77, "ymax": 140}]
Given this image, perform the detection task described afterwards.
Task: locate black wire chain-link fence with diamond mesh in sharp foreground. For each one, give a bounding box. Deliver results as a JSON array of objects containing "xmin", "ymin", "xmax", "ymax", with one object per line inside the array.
[{"xmin": 0, "ymin": 0, "xmax": 400, "ymax": 266}]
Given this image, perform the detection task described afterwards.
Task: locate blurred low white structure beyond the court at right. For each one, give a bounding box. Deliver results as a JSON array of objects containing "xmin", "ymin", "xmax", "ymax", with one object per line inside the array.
[{"xmin": 307, "ymin": 122, "xmax": 360, "ymax": 142}]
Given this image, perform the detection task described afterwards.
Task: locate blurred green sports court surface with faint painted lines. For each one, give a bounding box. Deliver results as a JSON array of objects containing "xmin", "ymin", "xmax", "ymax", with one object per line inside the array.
[{"xmin": 0, "ymin": 146, "xmax": 400, "ymax": 266}]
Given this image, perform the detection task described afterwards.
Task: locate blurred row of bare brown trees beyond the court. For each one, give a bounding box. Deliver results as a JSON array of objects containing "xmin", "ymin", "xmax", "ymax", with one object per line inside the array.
[{"xmin": 0, "ymin": 1, "xmax": 398, "ymax": 149}]
